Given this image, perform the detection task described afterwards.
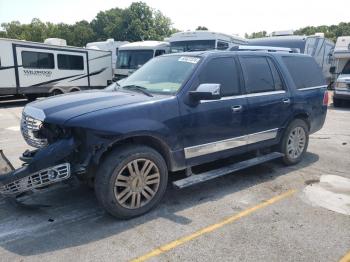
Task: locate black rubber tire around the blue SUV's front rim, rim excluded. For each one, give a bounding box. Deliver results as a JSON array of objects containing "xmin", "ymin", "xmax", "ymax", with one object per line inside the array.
[{"xmin": 95, "ymin": 145, "xmax": 168, "ymax": 219}]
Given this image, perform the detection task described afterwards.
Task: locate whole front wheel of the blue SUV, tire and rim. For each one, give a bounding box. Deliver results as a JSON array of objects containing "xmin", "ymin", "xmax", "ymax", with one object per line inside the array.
[{"xmin": 95, "ymin": 146, "xmax": 168, "ymax": 219}]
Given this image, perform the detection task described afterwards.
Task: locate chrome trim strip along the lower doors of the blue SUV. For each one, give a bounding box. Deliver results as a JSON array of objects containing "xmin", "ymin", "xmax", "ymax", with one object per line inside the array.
[{"xmin": 184, "ymin": 128, "xmax": 278, "ymax": 159}]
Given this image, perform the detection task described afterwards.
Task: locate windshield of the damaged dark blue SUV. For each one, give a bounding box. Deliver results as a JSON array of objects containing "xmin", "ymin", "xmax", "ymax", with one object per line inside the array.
[{"xmin": 119, "ymin": 56, "xmax": 200, "ymax": 94}]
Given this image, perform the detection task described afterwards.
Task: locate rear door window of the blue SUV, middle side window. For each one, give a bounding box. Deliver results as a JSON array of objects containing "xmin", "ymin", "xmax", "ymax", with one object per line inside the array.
[{"xmin": 241, "ymin": 56, "xmax": 275, "ymax": 93}]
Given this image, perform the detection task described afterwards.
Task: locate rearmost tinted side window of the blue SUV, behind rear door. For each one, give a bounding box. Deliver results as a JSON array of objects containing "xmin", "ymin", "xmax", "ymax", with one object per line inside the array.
[{"xmin": 283, "ymin": 56, "xmax": 326, "ymax": 89}]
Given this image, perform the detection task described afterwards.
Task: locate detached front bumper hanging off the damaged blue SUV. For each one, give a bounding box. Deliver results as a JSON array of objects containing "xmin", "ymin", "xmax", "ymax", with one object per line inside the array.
[{"xmin": 0, "ymin": 138, "xmax": 77, "ymax": 196}]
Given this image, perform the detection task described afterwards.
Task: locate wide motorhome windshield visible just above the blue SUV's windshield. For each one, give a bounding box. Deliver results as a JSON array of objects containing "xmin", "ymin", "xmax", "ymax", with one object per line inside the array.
[{"xmin": 170, "ymin": 40, "xmax": 215, "ymax": 53}]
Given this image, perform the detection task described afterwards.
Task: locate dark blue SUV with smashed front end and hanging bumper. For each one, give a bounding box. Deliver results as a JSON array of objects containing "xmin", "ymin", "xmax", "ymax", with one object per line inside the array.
[{"xmin": 0, "ymin": 51, "xmax": 328, "ymax": 218}]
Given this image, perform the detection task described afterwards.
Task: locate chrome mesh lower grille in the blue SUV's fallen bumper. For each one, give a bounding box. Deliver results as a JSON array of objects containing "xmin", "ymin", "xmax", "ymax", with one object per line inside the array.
[{"xmin": 0, "ymin": 163, "xmax": 71, "ymax": 195}]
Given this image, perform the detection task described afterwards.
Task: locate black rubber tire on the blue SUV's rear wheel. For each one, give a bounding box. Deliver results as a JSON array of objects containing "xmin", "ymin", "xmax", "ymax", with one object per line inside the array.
[{"xmin": 279, "ymin": 119, "xmax": 309, "ymax": 165}]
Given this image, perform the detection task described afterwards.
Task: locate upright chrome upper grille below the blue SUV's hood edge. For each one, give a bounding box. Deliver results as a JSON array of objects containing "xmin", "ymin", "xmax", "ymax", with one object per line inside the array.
[{"xmin": 21, "ymin": 113, "xmax": 47, "ymax": 148}]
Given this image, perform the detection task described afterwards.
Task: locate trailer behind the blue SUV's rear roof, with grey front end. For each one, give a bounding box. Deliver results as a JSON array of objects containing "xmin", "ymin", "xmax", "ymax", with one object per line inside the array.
[{"xmin": 248, "ymin": 34, "xmax": 334, "ymax": 85}]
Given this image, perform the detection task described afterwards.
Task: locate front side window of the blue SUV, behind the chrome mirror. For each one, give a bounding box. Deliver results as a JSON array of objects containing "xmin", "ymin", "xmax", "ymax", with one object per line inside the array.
[{"xmin": 199, "ymin": 57, "xmax": 240, "ymax": 96}]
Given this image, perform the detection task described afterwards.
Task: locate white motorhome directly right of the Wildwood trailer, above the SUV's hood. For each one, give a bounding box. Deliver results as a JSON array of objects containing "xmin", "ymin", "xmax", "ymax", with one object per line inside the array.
[{"xmin": 116, "ymin": 41, "xmax": 170, "ymax": 79}]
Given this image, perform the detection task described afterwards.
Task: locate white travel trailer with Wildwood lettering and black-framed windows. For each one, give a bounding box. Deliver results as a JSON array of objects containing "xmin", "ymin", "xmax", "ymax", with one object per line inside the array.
[{"xmin": 0, "ymin": 38, "xmax": 112, "ymax": 99}]
